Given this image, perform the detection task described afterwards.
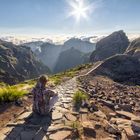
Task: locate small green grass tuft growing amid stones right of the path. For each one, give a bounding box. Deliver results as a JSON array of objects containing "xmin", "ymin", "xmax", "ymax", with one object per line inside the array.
[{"xmin": 73, "ymin": 90, "xmax": 88, "ymax": 110}]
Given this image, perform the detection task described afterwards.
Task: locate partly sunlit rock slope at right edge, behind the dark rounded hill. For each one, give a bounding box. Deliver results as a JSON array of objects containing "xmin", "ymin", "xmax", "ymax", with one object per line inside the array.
[{"xmin": 125, "ymin": 38, "xmax": 140, "ymax": 60}]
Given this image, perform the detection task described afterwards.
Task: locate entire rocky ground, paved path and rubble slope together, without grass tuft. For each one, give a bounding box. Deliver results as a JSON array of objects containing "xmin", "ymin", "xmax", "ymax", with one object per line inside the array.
[{"xmin": 0, "ymin": 75, "xmax": 140, "ymax": 140}]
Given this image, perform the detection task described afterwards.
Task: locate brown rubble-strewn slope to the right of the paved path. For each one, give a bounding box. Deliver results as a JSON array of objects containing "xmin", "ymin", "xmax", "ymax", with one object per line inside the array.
[{"xmin": 79, "ymin": 75, "xmax": 140, "ymax": 140}]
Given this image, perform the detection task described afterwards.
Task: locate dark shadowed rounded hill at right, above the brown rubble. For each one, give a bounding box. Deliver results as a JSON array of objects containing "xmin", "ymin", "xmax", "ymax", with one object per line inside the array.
[{"xmin": 90, "ymin": 55, "xmax": 140, "ymax": 85}]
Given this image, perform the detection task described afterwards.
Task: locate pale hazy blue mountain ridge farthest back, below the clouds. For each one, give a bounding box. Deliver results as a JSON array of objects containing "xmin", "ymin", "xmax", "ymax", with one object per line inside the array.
[{"xmin": 26, "ymin": 38, "xmax": 95, "ymax": 72}]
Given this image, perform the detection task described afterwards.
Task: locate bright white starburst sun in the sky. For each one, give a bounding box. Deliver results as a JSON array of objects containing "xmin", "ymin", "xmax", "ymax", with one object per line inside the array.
[{"xmin": 69, "ymin": 0, "xmax": 90, "ymax": 22}]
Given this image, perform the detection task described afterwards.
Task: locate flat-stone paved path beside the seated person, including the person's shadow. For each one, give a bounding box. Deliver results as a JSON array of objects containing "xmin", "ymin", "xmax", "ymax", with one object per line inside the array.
[{"xmin": 0, "ymin": 78, "xmax": 77, "ymax": 140}]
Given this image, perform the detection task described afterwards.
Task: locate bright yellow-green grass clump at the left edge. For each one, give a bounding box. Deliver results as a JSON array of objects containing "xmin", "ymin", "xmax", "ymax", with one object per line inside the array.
[{"xmin": 0, "ymin": 86, "xmax": 27, "ymax": 103}]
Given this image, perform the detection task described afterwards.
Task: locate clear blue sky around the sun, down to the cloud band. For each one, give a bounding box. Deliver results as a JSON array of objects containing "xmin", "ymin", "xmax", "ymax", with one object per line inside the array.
[{"xmin": 0, "ymin": 0, "xmax": 140, "ymax": 35}]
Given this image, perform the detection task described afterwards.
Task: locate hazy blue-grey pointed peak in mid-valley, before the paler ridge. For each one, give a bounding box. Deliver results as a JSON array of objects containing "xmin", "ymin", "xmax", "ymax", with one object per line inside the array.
[{"xmin": 54, "ymin": 47, "xmax": 88, "ymax": 73}]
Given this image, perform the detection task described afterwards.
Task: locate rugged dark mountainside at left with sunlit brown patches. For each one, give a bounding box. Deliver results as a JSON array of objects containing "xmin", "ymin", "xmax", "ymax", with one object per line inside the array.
[{"xmin": 0, "ymin": 41, "xmax": 49, "ymax": 84}]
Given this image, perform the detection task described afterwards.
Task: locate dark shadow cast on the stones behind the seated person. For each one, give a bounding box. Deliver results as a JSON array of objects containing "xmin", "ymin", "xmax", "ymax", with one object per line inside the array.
[{"xmin": 4, "ymin": 113, "xmax": 52, "ymax": 140}]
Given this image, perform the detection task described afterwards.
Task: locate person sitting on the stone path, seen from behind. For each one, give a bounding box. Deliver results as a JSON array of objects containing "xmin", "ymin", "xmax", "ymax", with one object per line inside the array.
[{"xmin": 32, "ymin": 75, "xmax": 58, "ymax": 115}]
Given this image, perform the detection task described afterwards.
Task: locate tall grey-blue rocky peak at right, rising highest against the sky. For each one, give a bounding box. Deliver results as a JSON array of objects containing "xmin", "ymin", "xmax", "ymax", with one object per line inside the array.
[{"xmin": 90, "ymin": 31, "xmax": 129, "ymax": 62}]
